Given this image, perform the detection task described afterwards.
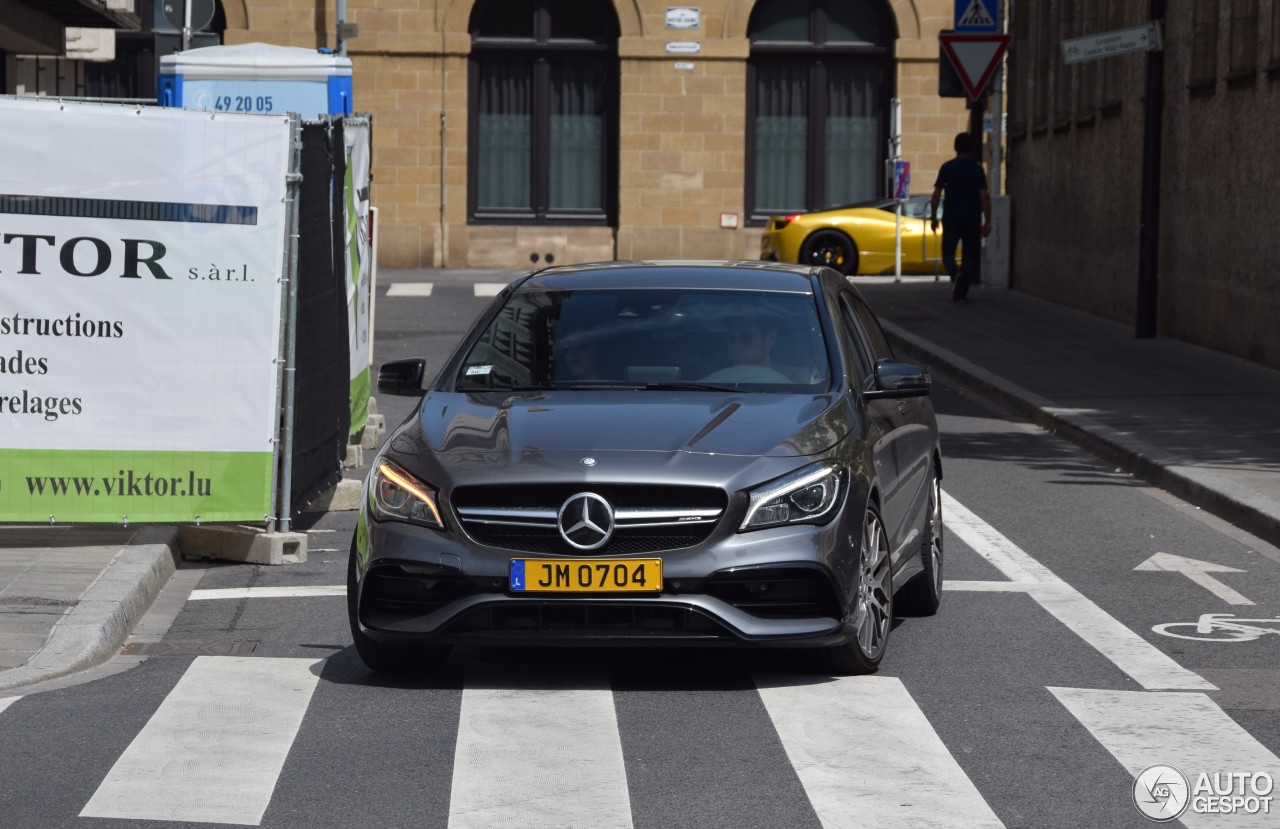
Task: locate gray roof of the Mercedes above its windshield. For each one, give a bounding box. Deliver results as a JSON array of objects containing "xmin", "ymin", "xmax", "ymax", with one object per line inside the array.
[{"xmin": 520, "ymin": 260, "xmax": 820, "ymax": 293}]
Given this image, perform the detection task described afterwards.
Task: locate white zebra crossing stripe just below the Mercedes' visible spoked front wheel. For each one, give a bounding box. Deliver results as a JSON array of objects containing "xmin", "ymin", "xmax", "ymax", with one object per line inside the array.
[{"xmin": 755, "ymin": 675, "xmax": 1004, "ymax": 829}]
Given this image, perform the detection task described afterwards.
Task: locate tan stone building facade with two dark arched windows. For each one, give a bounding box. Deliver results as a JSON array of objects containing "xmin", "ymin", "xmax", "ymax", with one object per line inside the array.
[{"xmin": 207, "ymin": 0, "xmax": 968, "ymax": 269}]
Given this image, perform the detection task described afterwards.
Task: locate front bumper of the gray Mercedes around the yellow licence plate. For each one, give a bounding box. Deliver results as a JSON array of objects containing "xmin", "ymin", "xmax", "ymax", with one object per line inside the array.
[{"xmin": 356, "ymin": 519, "xmax": 852, "ymax": 647}]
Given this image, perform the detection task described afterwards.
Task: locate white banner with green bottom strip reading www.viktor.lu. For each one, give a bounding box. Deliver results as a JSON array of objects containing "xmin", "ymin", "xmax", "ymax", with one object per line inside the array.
[{"xmin": 0, "ymin": 99, "xmax": 292, "ymax": 521}]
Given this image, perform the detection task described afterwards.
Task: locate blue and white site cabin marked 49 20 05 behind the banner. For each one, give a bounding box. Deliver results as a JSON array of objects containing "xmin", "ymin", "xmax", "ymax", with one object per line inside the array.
[{"xmin": 156, "ymin": 43, "xmax": 352, "ymax": 118}]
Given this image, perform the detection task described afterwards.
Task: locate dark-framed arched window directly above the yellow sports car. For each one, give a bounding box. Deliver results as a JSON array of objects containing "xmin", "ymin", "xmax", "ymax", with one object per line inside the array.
[{"xmin": 746, "ymin": 0, "xmax": 897, "ymax": 221}]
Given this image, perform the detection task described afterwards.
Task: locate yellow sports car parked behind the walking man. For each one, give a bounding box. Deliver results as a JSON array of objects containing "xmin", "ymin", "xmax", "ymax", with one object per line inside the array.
[{"xmin": 760, "ymin": 196, "xmax": 960, "ymax": 276}]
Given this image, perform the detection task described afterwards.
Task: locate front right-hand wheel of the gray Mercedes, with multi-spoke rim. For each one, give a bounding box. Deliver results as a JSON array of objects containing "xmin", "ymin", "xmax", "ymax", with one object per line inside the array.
[{"xmin": 818, "ymin": 504, "xmax": 893, "ymax": 675}]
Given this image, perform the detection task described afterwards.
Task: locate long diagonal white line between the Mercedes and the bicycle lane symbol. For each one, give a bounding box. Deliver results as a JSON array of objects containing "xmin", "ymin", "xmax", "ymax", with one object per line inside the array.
[{"xmin": 942, "ymin": 494, "xmax": 1217, "ymax": 691}]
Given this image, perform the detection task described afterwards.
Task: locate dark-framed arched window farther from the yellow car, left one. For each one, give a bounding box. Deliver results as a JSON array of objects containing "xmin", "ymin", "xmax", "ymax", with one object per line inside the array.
[{"xmin": 467, "ymin": 0, "xmax": 618, "ymax": 224}]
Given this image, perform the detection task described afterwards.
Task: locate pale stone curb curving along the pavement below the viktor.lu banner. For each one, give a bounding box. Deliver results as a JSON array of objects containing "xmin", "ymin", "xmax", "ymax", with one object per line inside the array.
[{"xmin": 0, "ymin": 527, "xmax": 178, "ymax": 691}]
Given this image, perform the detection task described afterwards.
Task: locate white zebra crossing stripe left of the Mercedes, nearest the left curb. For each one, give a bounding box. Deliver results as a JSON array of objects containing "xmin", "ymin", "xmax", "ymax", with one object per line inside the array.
[{"xmin": 81, "ymin": 656, "xmax": 324, "ymax": 826}]
